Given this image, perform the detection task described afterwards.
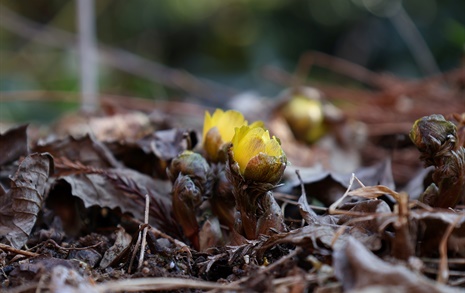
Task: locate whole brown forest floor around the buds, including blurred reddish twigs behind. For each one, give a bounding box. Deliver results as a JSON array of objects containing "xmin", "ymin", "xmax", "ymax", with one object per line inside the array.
[{"xmin": 0, "ymin": 69, "xmax": 465, "ymax": 293}]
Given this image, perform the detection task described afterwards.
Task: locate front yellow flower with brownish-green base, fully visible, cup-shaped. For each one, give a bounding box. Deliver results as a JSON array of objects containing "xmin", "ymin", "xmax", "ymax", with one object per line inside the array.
[{"xmin": 232, "ymin": 125, "xmax": 287, "ymax": 184}]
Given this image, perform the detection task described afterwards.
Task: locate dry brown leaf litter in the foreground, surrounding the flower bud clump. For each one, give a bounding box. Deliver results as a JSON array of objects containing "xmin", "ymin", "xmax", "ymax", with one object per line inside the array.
[{"xmin": 0, "ymin": 76, "xmax": 465, "ymax": 292}]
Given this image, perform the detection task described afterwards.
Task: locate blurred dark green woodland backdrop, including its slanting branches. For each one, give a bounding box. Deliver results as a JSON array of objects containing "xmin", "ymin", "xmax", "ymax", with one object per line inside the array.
[{"xmin": 0, "ymin": 0, "xmax": 465, "ymax": 122}]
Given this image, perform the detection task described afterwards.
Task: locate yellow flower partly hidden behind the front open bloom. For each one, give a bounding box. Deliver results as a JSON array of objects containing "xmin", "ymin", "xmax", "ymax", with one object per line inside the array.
[{"xmin": 203, "ymin": 109, "xmax": 263, "ymax": 162}]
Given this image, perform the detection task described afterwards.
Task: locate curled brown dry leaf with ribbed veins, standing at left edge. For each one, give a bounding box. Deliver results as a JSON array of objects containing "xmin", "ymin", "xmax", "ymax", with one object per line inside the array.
[{"xmin": 0, "ymin": 153, "xmax": 53, "ymax": 248}]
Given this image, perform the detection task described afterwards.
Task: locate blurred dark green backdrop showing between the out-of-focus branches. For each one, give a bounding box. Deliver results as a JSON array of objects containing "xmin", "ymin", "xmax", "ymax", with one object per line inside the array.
[{"xmin": 0, "ymin": 0, "xmax": 465, "ymax": 120}]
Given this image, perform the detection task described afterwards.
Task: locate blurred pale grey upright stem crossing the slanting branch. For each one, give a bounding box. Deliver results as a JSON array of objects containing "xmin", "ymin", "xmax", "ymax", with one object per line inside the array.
[{"xmin": 77, "ymin": 0, "xmax": 99, "ymax": 113}]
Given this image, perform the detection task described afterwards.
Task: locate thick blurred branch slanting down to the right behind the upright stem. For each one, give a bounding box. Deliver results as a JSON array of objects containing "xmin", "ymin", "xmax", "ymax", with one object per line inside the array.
[{"xmin": 0, "ymin": 5, "xmax": 237, "ymax": 105}]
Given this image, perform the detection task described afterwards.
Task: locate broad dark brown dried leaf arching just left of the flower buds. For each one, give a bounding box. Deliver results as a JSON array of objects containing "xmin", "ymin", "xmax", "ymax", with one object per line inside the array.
[{"xmin": 50, "ymin": 165, "xmax": 177, "ymax": 232}]
